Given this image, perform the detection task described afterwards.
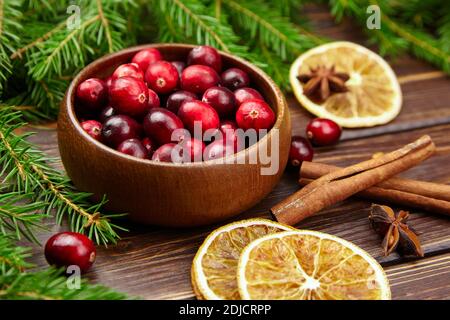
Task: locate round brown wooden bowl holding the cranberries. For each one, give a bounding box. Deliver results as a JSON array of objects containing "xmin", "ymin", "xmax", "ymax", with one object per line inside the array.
[{"xmin": 58, "ymin": 44, "xmax": 291, "ymax": 227}]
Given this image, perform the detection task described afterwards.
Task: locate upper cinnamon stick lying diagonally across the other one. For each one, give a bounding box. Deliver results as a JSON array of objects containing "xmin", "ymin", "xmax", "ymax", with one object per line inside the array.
[{"xmin": 271, "ymin": 135, "xmax": 436, "ymax": 225}]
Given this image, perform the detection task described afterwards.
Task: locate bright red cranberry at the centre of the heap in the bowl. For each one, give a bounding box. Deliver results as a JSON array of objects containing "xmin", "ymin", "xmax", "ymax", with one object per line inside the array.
[{"xmin": 178, "ymin": 100, "xmax": 220, "ymax": 134}]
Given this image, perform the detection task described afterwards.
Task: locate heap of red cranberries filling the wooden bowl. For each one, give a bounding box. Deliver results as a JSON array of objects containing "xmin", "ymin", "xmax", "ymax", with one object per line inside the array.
[{"xmin": 76, "ymin": 46, "xmax": 275, "ymax": 163}]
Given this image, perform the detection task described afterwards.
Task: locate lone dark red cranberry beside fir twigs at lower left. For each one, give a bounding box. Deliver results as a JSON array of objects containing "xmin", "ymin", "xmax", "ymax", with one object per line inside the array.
[{"xmin": 44, "ymin": 232, "xmax": 96, "ymax": 272}]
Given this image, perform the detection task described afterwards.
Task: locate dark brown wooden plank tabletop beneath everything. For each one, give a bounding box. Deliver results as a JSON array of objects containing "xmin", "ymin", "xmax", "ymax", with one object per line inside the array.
[{"xmin": 25, "ymin": 6, "xmax": 450, "ymax": 299}]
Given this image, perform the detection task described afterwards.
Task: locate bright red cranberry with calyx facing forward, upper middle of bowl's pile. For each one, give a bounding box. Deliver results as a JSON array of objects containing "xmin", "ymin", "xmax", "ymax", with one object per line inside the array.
[{"xmin": 145, "ymin": 61, "xmax": 179, "ymax": 94}]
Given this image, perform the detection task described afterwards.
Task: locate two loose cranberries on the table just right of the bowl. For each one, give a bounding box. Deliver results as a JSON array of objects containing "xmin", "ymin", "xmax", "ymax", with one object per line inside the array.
[{"xmin": 289, "ymin": 118, "xmax": 342, "ymax": 167}]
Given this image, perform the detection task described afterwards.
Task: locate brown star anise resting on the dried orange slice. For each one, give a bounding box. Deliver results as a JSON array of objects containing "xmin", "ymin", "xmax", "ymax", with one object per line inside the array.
[{"xmin": 297, "ymin": 65, "xmax": 350, "ymax": 102}]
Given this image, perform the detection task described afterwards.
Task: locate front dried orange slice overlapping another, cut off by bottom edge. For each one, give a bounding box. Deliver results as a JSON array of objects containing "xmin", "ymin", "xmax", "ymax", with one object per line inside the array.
[{"xmin": 238, "ymin": 230, "xmax": 391, "ymax": 300}]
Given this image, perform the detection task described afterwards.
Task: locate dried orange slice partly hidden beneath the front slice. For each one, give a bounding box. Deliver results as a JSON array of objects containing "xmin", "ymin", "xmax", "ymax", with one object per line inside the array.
[{"xmin": 191, "ymin": 219, "xmax": 294, "ymax": 300}]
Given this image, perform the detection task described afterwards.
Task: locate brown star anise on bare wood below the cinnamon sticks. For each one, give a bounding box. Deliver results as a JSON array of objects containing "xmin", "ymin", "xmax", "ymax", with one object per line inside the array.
[{"xmin": 369, "ymin": 204, "xmax": 423, "ymax": 257}]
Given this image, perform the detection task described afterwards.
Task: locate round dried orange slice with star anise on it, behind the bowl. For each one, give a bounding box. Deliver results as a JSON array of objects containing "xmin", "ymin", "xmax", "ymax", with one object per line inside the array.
[{"xmin": 289, "ymin": 41, "xmax": 402, "ymax": 128}]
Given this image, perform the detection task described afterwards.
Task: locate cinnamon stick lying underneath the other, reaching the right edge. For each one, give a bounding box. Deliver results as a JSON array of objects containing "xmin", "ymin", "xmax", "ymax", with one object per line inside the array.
[{"xmin": 299, "ymin": 178, "xmax": 450, "ymax": 215}]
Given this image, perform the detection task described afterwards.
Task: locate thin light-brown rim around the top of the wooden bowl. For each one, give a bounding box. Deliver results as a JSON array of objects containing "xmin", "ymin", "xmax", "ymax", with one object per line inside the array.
[{"xmin": 64, "ymin": 43, "xmax": 287, "ymax": 167}]
